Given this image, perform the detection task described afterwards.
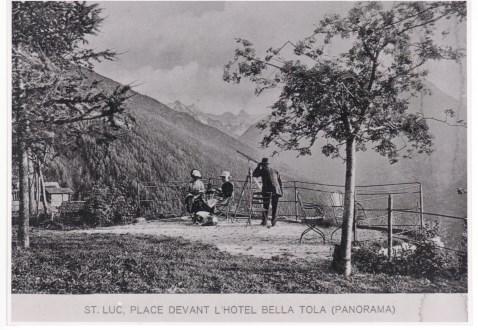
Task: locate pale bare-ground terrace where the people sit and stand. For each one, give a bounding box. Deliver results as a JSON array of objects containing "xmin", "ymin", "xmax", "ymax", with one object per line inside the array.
[{"xmin": 72, "ymin": 219, "xmax": 379, "ymax": 260}]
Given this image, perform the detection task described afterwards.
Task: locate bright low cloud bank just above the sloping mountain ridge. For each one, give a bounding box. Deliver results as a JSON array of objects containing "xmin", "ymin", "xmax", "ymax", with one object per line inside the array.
[{"xmin": 101, "ymin": 62, "xmax": 278, "ymax": 113}]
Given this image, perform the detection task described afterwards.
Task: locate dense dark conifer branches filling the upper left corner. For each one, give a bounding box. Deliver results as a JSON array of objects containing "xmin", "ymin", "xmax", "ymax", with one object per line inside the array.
[{"xmin": 12, "ymin": 2, "xmax": 134, "ymax": 162}]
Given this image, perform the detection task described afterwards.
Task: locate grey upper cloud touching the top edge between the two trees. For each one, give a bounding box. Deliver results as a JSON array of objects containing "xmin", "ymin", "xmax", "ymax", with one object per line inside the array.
[{"xmin": 92, "ymin": 2, "xmax": 349, "ymax": 68}]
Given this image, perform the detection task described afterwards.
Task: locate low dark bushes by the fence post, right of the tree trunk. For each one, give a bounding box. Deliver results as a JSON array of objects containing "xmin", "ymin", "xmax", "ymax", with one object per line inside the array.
[{"xmin": 353, "ymin": 223, "xmax": 467, "ymax": 280}]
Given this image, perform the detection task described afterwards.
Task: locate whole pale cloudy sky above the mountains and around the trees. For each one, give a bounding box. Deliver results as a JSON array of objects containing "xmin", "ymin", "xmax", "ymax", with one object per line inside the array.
[{"xmin": 90, "ymin": 1, "xmax": 466, "ymax": 113}]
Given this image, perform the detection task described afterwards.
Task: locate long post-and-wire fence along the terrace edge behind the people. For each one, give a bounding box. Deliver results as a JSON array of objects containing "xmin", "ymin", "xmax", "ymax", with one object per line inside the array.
[{"xmin": 137, "ymin": 178, "xmax": 466, "ymax": 253}]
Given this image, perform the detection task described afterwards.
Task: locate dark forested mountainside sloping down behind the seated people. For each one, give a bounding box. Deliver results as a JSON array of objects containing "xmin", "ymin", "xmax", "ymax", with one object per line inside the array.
[{"xmin": 41, "ymin": 73, "xmax": 260, "ymax": 208}]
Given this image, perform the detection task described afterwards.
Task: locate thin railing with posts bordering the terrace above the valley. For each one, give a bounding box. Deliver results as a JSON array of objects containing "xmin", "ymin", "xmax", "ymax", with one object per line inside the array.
[{"xmin": 137, "ymin": 178, "xmax": 466, "ymax": 253}]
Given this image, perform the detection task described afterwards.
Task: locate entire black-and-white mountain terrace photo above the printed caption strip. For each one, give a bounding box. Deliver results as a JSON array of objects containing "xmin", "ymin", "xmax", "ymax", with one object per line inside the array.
[{"xmin": 9, "ymin": 1, "xmax": 468, "ymax": 306}]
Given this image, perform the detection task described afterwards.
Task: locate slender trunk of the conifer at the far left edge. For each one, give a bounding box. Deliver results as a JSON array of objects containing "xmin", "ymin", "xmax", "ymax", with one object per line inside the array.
[{"xmin": 17, "ymin": 136, "xmax": 30, "ymax": 248}]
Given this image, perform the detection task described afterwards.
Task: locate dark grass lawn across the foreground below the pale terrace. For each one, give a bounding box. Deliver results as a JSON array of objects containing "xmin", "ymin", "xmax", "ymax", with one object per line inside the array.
[{"xmin": 12, "ymin": 230, "xmax": 466, "ymax": 294}]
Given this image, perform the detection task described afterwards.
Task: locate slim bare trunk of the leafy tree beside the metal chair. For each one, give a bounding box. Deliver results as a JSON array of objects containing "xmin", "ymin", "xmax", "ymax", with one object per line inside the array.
[{"xmin": 338, "ymin": 138, "xmax": 355, "ymax": 277}]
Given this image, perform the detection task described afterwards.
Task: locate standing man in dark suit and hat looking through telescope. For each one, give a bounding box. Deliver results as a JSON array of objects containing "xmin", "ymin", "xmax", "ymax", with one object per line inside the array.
[{"xmin": 252, "ymin": 158, "xmax": 282, "ymax": 226}]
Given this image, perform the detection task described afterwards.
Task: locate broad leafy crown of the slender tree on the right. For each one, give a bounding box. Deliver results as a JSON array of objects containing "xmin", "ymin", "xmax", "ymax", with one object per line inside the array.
[{"xmin": 224, "ymin": 2, "xmax": 466, "ymax": 162}]
